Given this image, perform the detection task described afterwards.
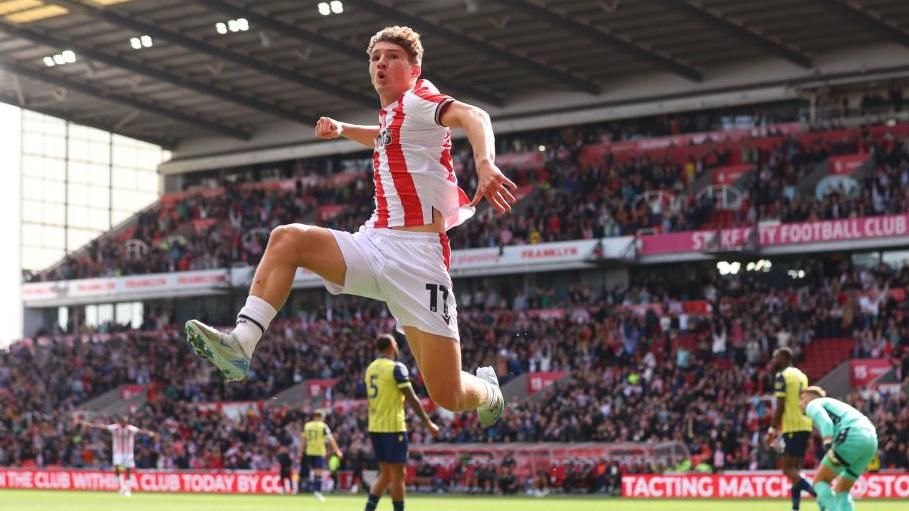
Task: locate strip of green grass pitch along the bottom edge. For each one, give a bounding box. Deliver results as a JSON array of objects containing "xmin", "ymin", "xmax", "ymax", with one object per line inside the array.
[{"xmin": 0, "ymin": 490, "xmax": 909, "ymax": 511}]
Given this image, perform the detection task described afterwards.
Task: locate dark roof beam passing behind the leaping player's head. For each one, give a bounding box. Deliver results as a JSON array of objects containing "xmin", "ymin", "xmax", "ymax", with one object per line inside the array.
[{"xmin": 194, "ymin": 0, "xmax": 505, "ymax": 107}]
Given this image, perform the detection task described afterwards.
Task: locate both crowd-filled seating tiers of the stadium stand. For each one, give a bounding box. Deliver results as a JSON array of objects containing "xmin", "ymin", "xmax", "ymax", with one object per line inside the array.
[{"xmin": 10, "ymin": 93, "xmax": 909, "ymax": 495}]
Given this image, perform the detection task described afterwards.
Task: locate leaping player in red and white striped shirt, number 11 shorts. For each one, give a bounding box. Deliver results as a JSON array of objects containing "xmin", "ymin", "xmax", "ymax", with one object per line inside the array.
[{"xmin": 186, "ymin": 27, "xmax": 516, "ymax": 426}]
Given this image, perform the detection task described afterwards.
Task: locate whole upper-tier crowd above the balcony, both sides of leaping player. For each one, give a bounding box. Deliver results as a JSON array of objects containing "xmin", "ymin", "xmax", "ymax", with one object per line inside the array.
[{"xmin": 29, "ymin": 113, "xmax": 909, "ymax": 280}]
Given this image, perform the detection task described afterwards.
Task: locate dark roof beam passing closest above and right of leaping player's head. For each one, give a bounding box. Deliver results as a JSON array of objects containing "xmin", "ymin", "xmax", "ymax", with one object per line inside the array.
[{"xmin": 346, "ymin": 0, "xmax": 600, "ymax": 94}]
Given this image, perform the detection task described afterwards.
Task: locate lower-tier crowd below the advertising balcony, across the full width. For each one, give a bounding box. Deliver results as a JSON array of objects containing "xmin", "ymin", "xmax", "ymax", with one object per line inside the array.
[{"xmin": 0, "ymin": 259, "xmax": 909, "ymax": 491}]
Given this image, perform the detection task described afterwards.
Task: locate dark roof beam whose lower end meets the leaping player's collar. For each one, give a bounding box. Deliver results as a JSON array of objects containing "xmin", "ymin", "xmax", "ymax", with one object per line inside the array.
[{"xmin": 54, "ymin": 0, "xmax": 376, "ymax": 108}]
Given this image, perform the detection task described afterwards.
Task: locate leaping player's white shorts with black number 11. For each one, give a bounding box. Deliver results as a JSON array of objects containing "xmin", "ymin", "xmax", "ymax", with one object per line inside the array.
[{"xmin": 322, "ymin": 227, "xmax": 460, "ymax": 341}]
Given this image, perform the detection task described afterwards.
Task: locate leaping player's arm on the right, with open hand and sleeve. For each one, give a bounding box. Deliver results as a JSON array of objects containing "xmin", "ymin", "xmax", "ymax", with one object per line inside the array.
[{"xmin": 439, "ymin": 101, "xmax": 518, "ymax": 213}]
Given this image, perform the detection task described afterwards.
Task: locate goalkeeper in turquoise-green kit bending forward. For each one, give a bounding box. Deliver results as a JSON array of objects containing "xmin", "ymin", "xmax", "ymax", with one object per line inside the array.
[{"xmin": 800, "ymin": 387, "xmax": 877, "ymax": 511}]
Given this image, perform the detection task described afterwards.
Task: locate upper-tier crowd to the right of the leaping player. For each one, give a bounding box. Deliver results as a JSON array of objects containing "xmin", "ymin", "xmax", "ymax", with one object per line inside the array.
[{"xmin": 452, "ymin": 123, "xmax": 909, "ymax": 248}]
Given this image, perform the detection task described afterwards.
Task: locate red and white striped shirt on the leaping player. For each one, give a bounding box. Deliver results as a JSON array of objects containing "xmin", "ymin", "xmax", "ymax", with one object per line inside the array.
[{"xmin": 366, "ymin": 79, "xmax": 474, "ymax": 230}]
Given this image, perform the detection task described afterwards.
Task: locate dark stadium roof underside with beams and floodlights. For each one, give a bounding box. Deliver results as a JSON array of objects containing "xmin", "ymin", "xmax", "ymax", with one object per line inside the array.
[{"xmin": 0, "ymin": 0, "xmax": 909, "ymax": 147}]
